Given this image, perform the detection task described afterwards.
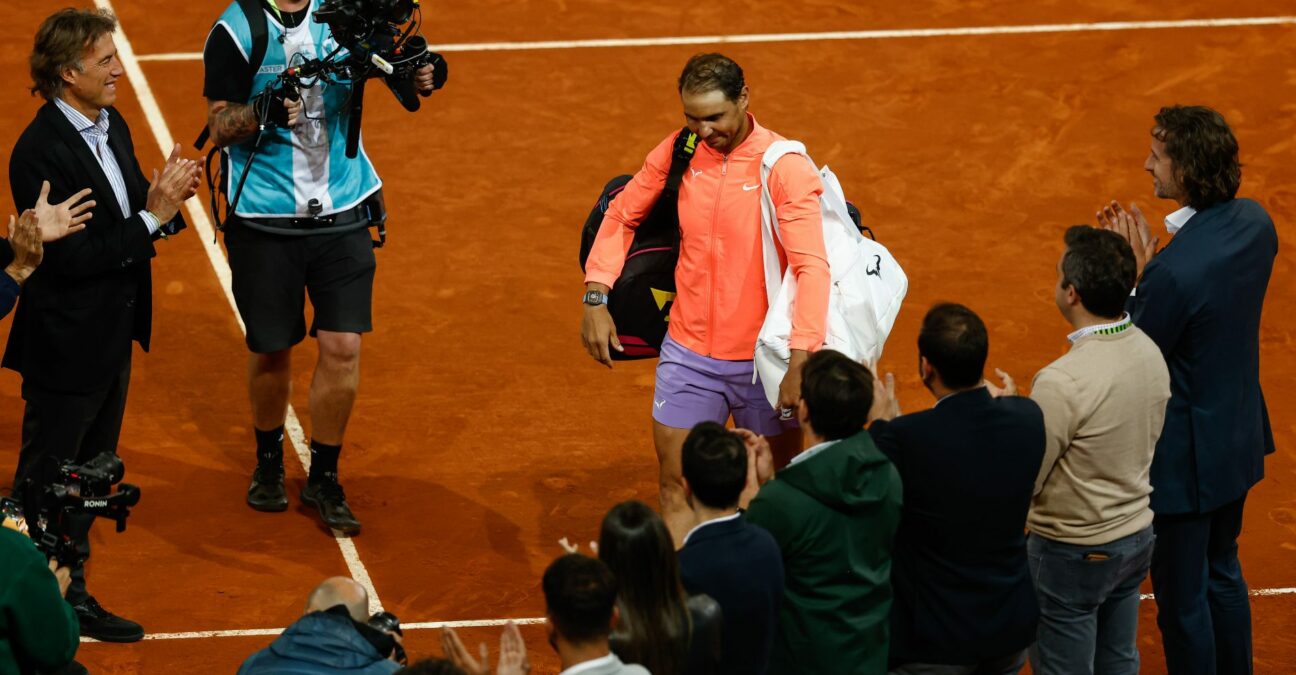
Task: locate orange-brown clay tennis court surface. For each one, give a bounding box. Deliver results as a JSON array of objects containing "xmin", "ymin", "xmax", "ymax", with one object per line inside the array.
[{"xmin": 0, "ymin": 0, "xmax": 1296, "ymax": 674}]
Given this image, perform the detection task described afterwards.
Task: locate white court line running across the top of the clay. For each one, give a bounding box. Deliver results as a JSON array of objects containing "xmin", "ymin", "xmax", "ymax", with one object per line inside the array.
[{"xmin": 131, "ymin": 17, "xmax": 1296, "ymax": 61}]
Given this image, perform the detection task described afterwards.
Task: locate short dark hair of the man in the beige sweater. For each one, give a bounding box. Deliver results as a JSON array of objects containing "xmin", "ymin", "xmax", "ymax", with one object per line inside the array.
[{"xmin": 1061, "ymin": 225, "xmax": 1135, "ymax": 319}]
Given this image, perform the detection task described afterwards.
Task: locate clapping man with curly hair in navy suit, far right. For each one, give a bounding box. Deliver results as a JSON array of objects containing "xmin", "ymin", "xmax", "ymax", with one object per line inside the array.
[{"xmin": 1099, "ymin": 106, "xmax": 1278, "ymax": 674}]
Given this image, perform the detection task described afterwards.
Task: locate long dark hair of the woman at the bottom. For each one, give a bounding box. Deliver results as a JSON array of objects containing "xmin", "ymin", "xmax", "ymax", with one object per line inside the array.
[{"xmin": 599, "ymin": 501, "xmax": 692, "ymax": 675}]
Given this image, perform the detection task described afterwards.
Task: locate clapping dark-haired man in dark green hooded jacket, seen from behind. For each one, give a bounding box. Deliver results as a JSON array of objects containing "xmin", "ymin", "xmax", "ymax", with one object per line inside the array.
[{"xmin": 745, "ymin": 350, "xmax": 901, "ymax": 675}]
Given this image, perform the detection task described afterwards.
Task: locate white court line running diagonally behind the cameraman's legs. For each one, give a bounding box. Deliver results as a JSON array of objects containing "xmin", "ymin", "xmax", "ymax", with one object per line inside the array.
[{"xmin": 95, "ymin": 0, "xmax": 382, "ymax": 614}]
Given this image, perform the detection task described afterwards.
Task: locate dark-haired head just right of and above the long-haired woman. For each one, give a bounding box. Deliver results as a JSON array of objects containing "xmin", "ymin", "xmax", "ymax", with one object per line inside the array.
[{"xmin": 682, "ymin": 422, "xmax": 746, "ymax": 509}]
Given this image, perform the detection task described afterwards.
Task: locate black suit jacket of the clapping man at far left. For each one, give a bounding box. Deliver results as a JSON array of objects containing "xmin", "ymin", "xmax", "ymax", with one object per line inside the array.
[{"xmin": 0, "ymin": 102, "xmax": 180, "ymax": 393}]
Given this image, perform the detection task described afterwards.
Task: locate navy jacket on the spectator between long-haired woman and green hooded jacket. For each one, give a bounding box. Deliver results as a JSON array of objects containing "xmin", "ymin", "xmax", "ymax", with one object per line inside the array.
[{"xmin": 679, "ymin": 518, "xmax": 783, "ymax": 675}]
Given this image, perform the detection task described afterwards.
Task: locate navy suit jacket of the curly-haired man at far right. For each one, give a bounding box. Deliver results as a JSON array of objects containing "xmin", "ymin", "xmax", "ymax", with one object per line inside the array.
[{"xmin": 1129, "ymin": 200, "xmax": 1278, "ymax": 516}]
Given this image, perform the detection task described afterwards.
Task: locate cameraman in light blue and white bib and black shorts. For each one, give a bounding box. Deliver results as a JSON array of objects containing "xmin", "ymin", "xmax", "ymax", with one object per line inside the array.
[{"xmin": 203, "ymin": 0, "xmax": 434, "ymax": 535}]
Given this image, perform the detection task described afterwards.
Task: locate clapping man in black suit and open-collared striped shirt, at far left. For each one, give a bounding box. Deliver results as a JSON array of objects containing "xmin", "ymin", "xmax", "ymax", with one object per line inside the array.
[{"xmin": 3, "ymin": 9, "xmax": 198, "ymax": 641}]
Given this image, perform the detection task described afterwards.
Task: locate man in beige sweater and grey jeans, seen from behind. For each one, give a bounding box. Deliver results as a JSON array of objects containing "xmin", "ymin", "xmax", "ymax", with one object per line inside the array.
[{"xmin": 1026, "ymin": 225, "xmax": 1170, "ymax": 675}]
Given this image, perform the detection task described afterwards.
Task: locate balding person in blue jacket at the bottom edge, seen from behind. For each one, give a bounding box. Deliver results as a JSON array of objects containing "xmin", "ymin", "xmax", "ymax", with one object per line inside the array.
[{"xmin": 238, "ymin": 577, "xmax": 400, "ymax": 675}]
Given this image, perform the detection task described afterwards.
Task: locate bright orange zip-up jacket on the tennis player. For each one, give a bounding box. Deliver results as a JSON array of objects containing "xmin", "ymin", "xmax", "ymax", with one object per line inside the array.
[{"xmin": 584, "ymin": 114, "xmax": 831, "ymax": 361}]
